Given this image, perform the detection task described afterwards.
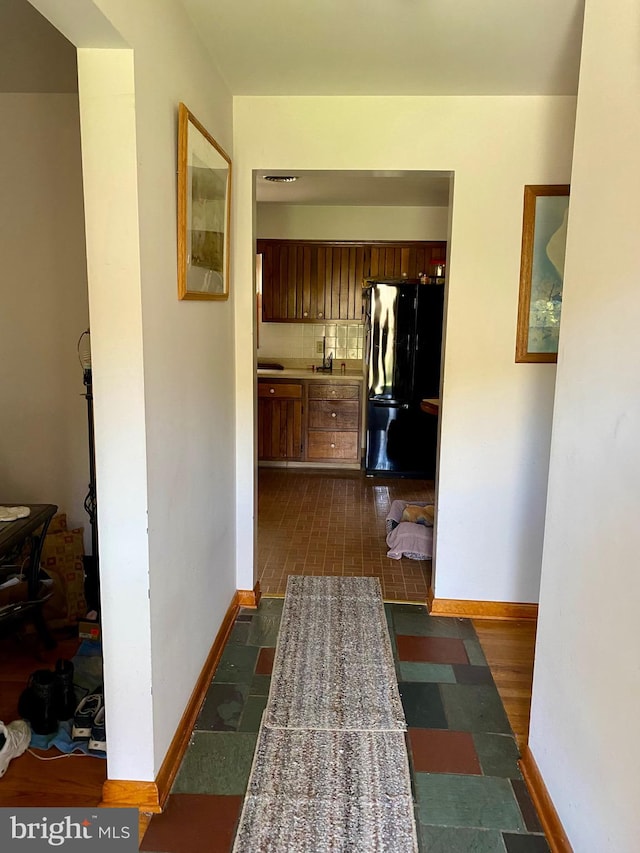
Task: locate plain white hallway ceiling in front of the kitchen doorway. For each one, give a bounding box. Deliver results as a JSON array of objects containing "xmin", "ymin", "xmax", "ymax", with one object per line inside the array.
[{"xmin": 182, "ymin": 0, "xmax": 584, "ymax": 95}]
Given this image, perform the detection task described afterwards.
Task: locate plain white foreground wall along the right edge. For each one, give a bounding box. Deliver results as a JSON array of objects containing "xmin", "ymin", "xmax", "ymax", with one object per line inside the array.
[{"xmin": 530, "ymin": 0, "xmax": 640, "ymax": 853}]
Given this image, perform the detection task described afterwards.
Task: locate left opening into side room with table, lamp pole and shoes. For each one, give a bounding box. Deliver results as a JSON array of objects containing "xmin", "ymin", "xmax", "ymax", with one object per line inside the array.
[{"xmin": 0, "ymin": 0, "xmax": 106, "ymax": 806}]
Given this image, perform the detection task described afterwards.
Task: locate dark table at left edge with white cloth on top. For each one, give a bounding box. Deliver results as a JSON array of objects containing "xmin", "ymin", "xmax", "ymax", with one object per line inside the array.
[{"xmin": 0, "ymin": 501, "xmax": 58, "ymax": 649}]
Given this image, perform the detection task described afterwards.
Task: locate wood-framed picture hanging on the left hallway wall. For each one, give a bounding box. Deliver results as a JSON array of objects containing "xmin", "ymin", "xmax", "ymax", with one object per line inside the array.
[{"xmin": 178, "ymin": 103, "xmax": 231, "ymax": 300}]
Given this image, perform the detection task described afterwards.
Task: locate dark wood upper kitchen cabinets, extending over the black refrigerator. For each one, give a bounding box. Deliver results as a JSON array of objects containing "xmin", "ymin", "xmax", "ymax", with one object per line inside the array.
[{"xmin": 257, "ymin": 240, "xmax": 447, "ymax": 323}]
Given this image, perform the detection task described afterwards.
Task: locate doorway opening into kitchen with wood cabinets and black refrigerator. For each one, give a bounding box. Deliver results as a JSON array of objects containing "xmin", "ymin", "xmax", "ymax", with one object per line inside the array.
[{"xmin": 254, "ymin": 171, "xmax": 452, "ymax": 604}]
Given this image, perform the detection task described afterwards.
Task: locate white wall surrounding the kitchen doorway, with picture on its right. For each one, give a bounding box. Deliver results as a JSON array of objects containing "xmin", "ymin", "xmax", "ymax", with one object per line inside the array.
[{"xmin": 234, "ymin": 97, "xmax": 575, "ymax": 601}]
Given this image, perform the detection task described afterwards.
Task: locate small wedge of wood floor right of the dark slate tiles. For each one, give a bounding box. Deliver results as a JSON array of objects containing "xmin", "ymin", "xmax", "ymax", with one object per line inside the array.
[{"xmin": 473, "ymin": 619, "xmax": 537, "ymax": 747}]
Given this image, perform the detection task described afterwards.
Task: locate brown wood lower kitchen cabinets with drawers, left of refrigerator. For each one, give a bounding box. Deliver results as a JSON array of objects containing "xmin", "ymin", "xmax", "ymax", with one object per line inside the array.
[{"xmin": 258, "ymin": 379, "xmax": 362, "ymax": 463}]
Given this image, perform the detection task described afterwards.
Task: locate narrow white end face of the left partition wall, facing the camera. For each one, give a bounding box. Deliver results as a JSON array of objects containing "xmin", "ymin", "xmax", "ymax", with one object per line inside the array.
[{"xmin": 78, "ymin": 49, "xmax": 154, "ymax": 780}]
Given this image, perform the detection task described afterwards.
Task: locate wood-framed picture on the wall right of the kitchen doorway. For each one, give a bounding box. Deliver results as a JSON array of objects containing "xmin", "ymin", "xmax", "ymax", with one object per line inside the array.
[{"xmin": 516, "ymin": 184, "xmax": 569, "ymax": 363}]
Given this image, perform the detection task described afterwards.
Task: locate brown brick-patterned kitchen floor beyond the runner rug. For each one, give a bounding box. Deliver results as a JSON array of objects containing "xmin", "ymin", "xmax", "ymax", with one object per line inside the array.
[{"xmin": 258, "ymin": 468, "xmax": 434, "ymax": 602}]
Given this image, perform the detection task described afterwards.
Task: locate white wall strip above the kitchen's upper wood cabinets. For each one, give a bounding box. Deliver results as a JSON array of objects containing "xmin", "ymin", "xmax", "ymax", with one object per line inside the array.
[{"xmin": 256, "ymin": 202, "xmax": 448, "ymax": 241}]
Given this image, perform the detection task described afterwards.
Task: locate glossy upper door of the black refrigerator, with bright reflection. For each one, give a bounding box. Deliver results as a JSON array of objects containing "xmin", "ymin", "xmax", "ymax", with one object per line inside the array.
[{"xmin": 364, "ymin": 283, "xmax": 417, "ymax": 403}]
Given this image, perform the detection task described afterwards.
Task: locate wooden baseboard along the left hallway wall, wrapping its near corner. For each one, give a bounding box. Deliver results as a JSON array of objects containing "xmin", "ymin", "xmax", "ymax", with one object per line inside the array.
[{"xmin": 100, "ymin": 586, "xmax": 241, "ymax": 814}]
